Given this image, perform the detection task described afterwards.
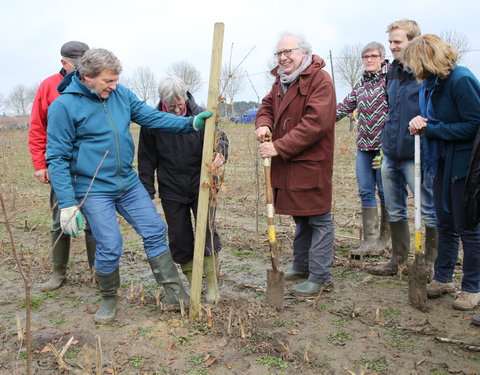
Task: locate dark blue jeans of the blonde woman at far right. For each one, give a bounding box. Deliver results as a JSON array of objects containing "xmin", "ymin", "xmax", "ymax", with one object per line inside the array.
[{"xmin": 433, "ymin": 162, "xmax": 480, "ymax": 293}]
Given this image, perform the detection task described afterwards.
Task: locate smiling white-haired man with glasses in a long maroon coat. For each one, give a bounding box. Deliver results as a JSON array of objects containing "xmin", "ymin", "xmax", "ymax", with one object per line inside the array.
[{"xmin": 255, "ymin": 34, "xmax": 336, "ymax": 295}]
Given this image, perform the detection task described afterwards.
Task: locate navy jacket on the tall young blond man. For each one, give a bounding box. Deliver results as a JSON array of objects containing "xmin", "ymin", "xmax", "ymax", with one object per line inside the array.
[{"xmin": 382, "ymin": 60, "xmax": 420, "ymax": 161}]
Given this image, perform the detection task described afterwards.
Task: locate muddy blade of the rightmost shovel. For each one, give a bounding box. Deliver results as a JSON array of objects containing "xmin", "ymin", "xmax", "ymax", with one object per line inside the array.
[{"xmin": 408, "ymin": 253, "xmax": 430, "ymax": 312}]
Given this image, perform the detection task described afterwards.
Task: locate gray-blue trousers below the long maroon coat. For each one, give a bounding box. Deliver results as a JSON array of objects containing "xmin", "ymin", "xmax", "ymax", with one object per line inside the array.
[{"xmin": 292, "ymin": 212, "xmax": 334, "ymax": 284}]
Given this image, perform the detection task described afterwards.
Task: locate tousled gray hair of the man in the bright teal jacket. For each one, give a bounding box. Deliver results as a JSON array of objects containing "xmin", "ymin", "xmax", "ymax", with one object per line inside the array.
[{"xmin": 78, "ymin": 48, "xmax": 122, "ymax": 78}]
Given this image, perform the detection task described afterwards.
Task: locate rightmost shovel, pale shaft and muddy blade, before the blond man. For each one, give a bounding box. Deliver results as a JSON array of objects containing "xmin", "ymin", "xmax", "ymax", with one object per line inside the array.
[{"xmin": 408, "ymin": 134, "xmax": 429, "ymax": 311}]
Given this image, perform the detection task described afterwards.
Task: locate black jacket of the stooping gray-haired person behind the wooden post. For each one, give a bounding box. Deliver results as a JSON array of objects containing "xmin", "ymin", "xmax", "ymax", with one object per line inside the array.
[{"xmin": 138, "ymin": 93, "xmax": 228, "ymax": 203}]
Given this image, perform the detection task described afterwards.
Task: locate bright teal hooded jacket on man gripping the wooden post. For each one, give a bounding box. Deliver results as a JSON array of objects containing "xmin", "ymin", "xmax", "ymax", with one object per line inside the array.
[{"xmin": 46, "ymin": 71, "xmax": 199, "ymax": 208}]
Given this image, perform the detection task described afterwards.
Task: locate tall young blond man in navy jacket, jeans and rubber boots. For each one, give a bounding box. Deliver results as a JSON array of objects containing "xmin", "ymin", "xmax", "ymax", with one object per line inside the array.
[{"xmin": 367, "ymin": 19, "xmax": 438, "ymax": 280}]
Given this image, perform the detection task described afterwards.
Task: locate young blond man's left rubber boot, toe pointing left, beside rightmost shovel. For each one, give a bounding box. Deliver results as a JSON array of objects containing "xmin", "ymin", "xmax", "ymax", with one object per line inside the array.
[{"xmin": 367, "ymin": 221, "xmax": 410, "ymax": 276}]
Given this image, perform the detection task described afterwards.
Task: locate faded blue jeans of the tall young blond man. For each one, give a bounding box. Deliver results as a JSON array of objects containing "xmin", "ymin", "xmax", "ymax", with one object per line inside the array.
[{"xmin": 382, "ymin": 154, "xmax": 437, "ymax": 228}]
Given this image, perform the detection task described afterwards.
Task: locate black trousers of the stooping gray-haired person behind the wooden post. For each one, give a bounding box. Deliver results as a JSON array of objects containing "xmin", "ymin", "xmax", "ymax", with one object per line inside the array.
[{"xmin": 162, "ymin": 199, "xmax": 222, "ymax": 264}]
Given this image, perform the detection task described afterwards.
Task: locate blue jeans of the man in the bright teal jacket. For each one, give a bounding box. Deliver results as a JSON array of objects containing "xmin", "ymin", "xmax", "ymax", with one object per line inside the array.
[{"xmin": 79, "ymin": 183, "xmax": 169, "ymax": 275}]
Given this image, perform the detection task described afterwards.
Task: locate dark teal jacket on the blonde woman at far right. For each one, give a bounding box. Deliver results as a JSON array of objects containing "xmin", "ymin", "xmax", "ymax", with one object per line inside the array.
[{"xmin": 422, "ymin": 65, "xmax": 480, "ymax": 212}]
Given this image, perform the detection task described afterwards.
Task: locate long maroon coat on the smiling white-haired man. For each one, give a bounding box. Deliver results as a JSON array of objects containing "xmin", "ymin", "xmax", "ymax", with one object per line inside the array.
[{"xmin": 255, "ymin": 55, "xmax": 336, "ymax": 216}]
